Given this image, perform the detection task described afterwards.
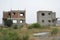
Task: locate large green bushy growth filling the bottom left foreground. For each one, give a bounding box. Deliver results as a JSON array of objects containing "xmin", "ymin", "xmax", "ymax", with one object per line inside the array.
[{"xmin": 0, "ymin": 29, "xmax": 21, "ymax": 40}]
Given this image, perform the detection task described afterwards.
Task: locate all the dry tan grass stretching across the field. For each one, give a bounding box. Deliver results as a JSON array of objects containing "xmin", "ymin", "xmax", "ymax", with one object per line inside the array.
[{"xmin": 0, "ymin": 26, "xmax": 60, "ymax": 40}]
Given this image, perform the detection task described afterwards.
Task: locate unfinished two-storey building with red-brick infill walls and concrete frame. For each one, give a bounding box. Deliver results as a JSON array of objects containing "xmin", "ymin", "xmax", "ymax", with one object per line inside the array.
[{"xmin": 3, "ymin": 10, "xmax": 26, "ymax": 24}]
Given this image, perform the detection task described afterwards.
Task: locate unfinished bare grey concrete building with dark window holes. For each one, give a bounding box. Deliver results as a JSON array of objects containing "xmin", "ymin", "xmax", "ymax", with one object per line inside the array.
[{"xmin": 37, "ymin": 11, "xmax": 56, "ymax": 26}]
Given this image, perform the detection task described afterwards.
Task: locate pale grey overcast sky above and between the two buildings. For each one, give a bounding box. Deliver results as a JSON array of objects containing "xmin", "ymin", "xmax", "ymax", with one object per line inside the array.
[{"xmin": 0, "ymin": 0, "xmax": 60, "ymax": 23}]
